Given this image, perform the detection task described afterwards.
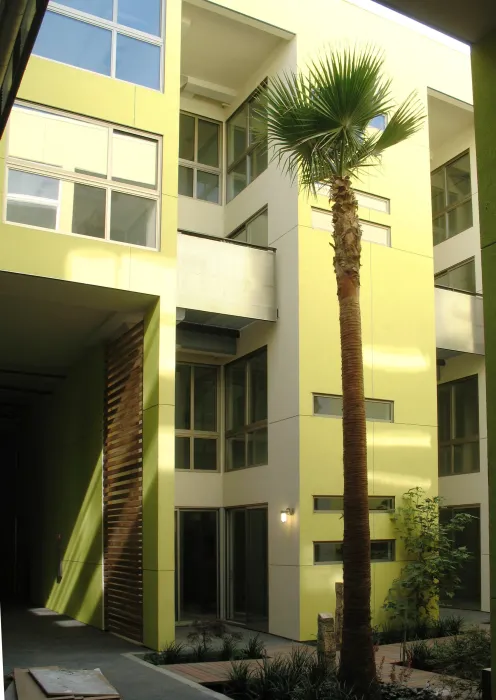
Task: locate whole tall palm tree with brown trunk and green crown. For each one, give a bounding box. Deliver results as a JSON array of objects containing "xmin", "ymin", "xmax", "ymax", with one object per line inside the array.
[{"xmin": 264, "ymin": 49, "xmax": 424, "ymax": 693}]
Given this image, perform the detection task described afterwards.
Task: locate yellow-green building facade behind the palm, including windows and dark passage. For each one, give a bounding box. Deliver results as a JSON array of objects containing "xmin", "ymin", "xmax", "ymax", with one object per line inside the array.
[{"xmin": 0, "ymin": 0, "xmax": 471, "ymax": 648}]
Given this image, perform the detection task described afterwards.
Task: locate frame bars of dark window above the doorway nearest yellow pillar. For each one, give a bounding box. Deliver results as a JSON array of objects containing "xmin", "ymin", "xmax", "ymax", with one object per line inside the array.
[{"xmin": 174, "ymin": 362, "xmax": 221, "ymax": 474}]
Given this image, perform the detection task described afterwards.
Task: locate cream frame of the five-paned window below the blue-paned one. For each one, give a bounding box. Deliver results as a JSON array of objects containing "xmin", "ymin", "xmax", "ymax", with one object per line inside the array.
[{"xmin": 2, "ymin": 100, "xmax": 162, "ymax": 251}]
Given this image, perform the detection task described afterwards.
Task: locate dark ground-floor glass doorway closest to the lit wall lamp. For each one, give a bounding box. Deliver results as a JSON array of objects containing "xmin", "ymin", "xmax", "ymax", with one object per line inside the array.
[{"xmin": 227, "ymin": 506, "xmax": 269, "ymax": 631}]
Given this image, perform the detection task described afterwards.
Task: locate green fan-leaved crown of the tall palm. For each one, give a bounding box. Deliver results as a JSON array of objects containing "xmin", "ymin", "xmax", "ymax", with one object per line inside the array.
[{"xmin": 264, "ymin": 49, "xmax": 424, "ymax": 189}]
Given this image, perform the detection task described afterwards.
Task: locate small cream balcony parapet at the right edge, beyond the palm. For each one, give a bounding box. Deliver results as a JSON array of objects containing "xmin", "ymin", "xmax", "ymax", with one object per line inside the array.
[{"xmin": 434, "ymin": 287, "xmax": 484, "ymax": 356}]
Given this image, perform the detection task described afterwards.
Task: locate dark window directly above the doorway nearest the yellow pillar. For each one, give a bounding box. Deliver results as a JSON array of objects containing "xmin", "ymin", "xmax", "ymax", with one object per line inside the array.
[{"xmin": 175, "ymin": 364, "xmax": 219, "ymax": 471}]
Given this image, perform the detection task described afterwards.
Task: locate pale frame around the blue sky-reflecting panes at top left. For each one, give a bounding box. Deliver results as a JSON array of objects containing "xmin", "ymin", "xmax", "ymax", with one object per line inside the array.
[{"xmin": 37, "ymin": 0, "xmax": 166, "ymax": 92}]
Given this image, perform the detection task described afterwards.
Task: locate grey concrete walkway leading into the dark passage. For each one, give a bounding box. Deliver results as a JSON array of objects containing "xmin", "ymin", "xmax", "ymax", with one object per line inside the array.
[{"xmin": 2, "ymin": 605, "xmax": 223, "ymax": 700}]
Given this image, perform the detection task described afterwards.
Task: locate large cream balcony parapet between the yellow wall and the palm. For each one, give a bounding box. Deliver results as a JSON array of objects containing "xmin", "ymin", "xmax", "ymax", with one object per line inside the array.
[{"xmin": 177, "ymin": 231, "xmax": 277, "ymax": 329}]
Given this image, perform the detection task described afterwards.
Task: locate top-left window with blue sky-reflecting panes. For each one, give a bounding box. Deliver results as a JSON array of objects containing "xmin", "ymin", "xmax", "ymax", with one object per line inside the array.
[{"xmin": 33, "ymin": 0, "xmax": 163, "ymax": 90}]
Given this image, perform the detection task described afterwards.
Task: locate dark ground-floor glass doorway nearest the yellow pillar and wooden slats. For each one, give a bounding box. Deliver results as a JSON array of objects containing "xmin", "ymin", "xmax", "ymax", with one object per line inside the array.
[{"xmin": 176, "ymin": 510, "xmax": 219, "ymax": 622}]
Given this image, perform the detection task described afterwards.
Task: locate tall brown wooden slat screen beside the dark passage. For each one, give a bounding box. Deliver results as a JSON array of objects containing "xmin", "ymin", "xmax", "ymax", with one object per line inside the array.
[{"xmin": 103, "ymin": 323, "xmax": 143, "ymax": 642}]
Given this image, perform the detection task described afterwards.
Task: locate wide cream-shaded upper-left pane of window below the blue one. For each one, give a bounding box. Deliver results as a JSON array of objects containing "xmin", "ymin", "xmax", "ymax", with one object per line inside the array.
[{"xmin": 9, "ymin": 107, "xmax": 109, "ymax": 176}]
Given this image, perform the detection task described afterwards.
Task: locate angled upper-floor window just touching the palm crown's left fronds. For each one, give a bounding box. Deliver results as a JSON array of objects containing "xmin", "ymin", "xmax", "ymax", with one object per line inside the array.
[{"xmin": 227, "ymin": 86, "xmax": 268, "ymax": 201}]
